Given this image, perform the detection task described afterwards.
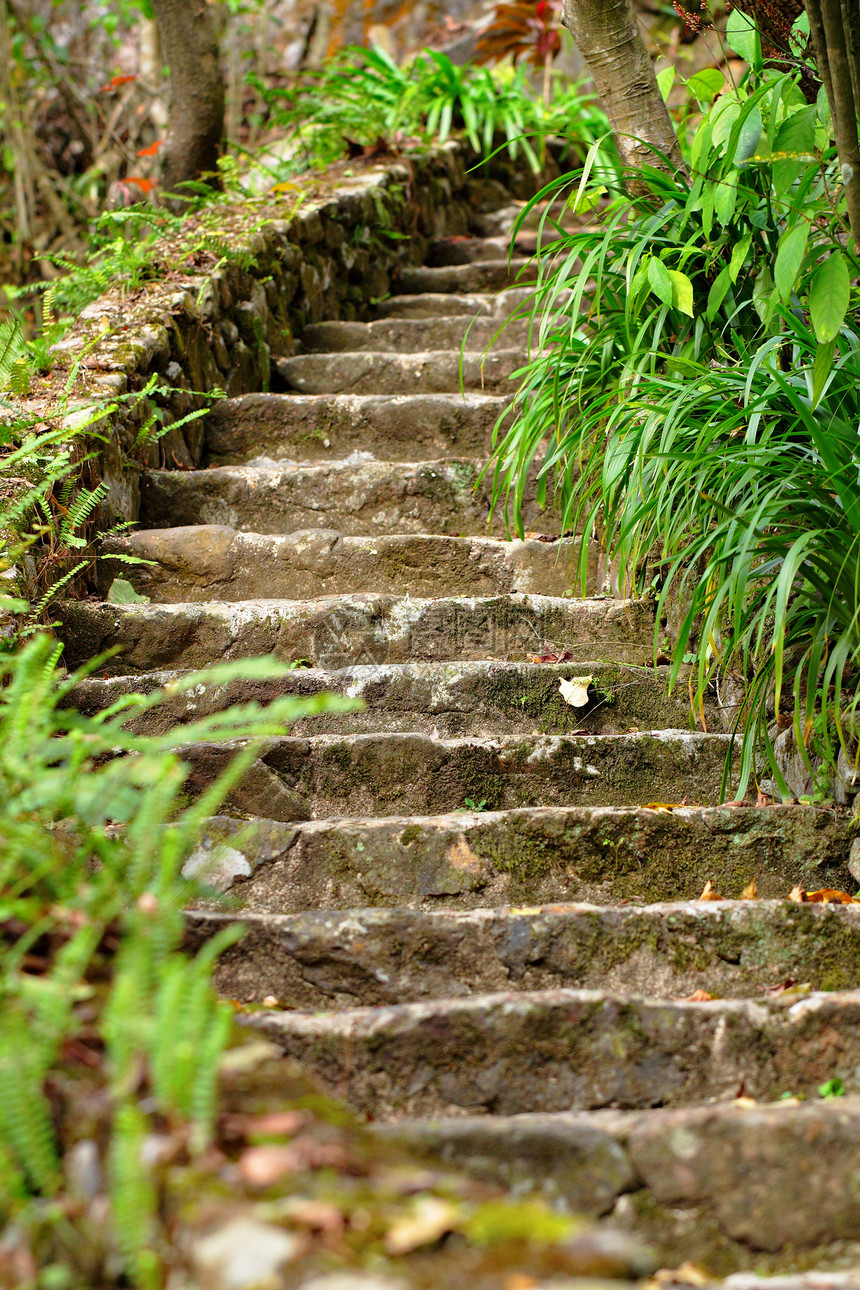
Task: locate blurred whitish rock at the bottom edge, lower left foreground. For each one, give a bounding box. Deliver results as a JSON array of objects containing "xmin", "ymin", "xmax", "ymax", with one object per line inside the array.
[{"xmin": 191, "ymin": 1216, "xmax": 304, "ymax": 1290}]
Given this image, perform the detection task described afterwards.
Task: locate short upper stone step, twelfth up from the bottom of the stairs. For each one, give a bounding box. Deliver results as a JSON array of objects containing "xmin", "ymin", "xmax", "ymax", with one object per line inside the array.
[{"xmin": 302, "ymin": 313, "xmax": 538, "ymax": 353}]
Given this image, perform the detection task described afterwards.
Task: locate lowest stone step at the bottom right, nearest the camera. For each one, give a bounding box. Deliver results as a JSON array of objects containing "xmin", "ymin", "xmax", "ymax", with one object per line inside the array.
[{"xmin": 379, "ymin": 1098, "xmax": 860, "ymax": 1269}]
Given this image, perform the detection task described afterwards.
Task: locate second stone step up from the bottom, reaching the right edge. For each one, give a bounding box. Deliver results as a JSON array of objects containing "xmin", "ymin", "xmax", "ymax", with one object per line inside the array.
[{"xmin": 248, "ymin": 989, "xmax": 860, "ymax": 1120}]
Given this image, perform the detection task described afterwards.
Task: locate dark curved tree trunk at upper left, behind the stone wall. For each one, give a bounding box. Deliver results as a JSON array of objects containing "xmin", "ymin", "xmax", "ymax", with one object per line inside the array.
[{"xmin": 152, "ymin": 0, "xmax": 224, "ymax": 192}]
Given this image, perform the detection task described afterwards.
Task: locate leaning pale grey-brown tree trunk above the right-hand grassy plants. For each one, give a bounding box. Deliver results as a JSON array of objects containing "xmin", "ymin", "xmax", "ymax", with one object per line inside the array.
[{"xmin": 562, "ymin": 0, "xmax": 686, "ymax": 190}]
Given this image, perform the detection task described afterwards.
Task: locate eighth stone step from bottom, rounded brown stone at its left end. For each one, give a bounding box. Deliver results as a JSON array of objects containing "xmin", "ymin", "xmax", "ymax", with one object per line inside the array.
[{"xmin": 99, "ymin": 526, "xmax": 585, "ymax": 602}]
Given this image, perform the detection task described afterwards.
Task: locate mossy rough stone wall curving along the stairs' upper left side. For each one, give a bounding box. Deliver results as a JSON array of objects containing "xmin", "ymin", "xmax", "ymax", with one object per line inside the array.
[{"xmin": 43, "ymin": 142, "xmax": 551, "ymax": 539}]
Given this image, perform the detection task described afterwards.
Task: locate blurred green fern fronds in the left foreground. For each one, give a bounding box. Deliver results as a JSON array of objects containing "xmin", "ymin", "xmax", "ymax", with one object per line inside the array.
[{"xmin": 0, "ymin": 635, "xmax": 355, "ymax": 1287}]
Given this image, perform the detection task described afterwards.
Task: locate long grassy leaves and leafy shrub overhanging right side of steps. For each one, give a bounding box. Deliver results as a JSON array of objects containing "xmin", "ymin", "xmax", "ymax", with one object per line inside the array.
[{"xmin": 494, "ymin": 30, "xmax": 860, "ymax": 791}]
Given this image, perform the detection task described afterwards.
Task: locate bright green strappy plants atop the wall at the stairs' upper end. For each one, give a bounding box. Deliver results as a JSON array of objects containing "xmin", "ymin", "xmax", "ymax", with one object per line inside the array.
[{"xmin": 257, "ymin": 48, "xmax": 607, "ymax": 175}]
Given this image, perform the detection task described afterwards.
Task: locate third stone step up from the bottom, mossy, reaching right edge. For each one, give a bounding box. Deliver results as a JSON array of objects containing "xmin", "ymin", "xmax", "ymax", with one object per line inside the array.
[{"xmin": 188, "ymin": 900, "xmax": 860, "ymax": 1009}]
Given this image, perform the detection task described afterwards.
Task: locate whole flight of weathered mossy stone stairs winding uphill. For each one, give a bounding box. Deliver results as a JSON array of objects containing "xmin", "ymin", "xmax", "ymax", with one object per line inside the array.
[{"xmin": 63, "ymin": 216, "xmax": 860, "ymax": 1284}]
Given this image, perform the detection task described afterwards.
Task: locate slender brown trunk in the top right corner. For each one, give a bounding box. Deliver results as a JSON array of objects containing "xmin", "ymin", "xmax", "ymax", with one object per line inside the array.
[{"xmin": 806, "ymin": 0, "xmax": 860, "ymax": 237}]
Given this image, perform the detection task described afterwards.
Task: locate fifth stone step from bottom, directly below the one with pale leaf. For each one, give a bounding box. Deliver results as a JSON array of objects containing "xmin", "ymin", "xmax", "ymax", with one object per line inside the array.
[{"xmin": 182, "ymin": 730, "xmax": 730, "ymax": 819}]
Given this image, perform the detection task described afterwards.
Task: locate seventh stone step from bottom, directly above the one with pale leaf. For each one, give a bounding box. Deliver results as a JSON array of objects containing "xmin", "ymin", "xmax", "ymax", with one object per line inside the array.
[{"xmin": 57, "ymin": 596, "xmax": 654, "ymax": 675}]
